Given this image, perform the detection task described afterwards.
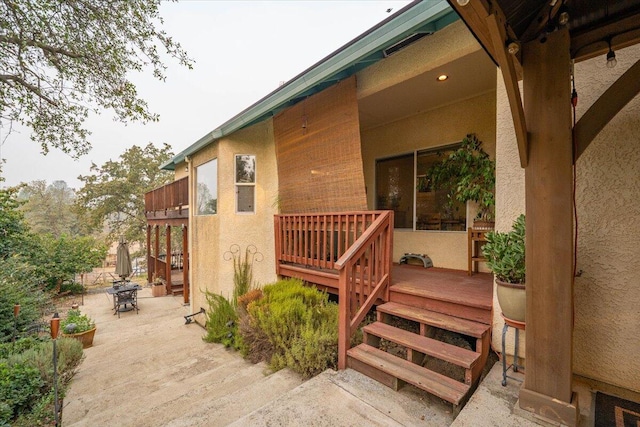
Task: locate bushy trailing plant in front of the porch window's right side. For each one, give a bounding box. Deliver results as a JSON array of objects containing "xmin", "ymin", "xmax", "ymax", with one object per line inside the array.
[{"xmin": 426, "ymin": 133, "xmax": 496, "ymax": 228}]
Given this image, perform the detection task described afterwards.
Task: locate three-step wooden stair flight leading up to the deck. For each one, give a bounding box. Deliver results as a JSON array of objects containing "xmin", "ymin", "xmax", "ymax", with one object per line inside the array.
[{"xmin": 347, "ymin": 301, "xmax": 491, "ymax": 412}]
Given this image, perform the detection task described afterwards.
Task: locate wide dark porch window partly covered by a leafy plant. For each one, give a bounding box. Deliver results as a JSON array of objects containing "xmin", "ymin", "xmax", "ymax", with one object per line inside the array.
[{"xmin": 376, "ymin": 144, "xmax": 467, "ymax": 231}]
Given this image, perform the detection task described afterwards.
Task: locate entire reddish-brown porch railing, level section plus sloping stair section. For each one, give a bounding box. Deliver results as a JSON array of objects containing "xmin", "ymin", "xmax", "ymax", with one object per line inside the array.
[{"xmin": 275, "ymin": 211, "xmax": 393, "ymax": 369}]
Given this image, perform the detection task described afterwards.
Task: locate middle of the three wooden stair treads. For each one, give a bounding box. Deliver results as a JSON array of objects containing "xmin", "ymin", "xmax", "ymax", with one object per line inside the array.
[{"xmin": 363, "ymin": 322, "xmax": 480, "ymax": 369}]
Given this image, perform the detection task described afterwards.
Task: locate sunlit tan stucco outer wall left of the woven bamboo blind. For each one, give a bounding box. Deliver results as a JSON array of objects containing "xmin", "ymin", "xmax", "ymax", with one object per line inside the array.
[{"xmin": 190, "ymin": 120, "xmax": 278, "ymax": 318}]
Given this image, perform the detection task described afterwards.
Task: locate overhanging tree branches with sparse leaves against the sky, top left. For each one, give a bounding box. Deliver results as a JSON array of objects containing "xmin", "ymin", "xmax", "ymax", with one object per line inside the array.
[{"xmin": 0, "ymin": 0, "xmax": 192, "ymax": 157}]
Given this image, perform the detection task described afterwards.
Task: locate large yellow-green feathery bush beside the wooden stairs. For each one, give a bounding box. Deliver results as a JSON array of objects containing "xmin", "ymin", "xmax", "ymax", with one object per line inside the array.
[{"xmin": 240, "ymin": 280, "xmax": 338, "ymax": 377}]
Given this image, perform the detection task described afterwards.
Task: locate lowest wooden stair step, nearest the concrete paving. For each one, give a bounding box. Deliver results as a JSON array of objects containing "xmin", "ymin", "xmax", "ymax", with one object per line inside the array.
[{"xmin": 347, "ymin": 344, "xmax": 470, "ymax": 405}]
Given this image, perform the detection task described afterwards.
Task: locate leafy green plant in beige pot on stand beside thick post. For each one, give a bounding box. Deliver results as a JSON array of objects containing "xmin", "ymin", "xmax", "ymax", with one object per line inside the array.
[{"xmin": 482, "ymin": 215, "xmax": 526, "ymax": 322}]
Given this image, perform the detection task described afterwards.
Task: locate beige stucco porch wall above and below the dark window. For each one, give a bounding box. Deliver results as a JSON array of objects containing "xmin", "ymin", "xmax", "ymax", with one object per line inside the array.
[{"xmin": 361, "ymin": 92, "xmax": 496, "ymax": 270}]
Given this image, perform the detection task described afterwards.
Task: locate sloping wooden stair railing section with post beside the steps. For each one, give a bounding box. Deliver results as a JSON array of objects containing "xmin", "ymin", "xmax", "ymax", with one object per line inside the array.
[{"xmin": 334, "ymin": 211, "xmax": 393, "ymax": 369}]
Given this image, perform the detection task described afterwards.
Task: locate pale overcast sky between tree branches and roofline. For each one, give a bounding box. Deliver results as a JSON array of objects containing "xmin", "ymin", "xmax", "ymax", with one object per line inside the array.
[{"xmin": 0, "ymin": 0, "xmax": 409, "ymax": 188}]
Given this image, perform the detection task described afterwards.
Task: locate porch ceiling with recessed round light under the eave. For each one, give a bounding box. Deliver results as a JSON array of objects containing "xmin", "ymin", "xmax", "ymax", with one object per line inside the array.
[{"xmin": 358, "ymin": 50, "xmax": 496, "ymax": 129}]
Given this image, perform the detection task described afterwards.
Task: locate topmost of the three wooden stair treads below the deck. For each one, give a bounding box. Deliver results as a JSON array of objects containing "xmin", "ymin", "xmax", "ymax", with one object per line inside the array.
[{"xmin": 377, "ymin": 302, "xmax": 490, "ymax": 338}]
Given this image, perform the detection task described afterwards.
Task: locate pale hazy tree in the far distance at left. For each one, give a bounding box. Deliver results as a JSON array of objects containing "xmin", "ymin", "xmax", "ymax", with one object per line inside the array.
[{"xmin": 18, "ymin": 180, "xmax": 79, "ymax": 237}]
